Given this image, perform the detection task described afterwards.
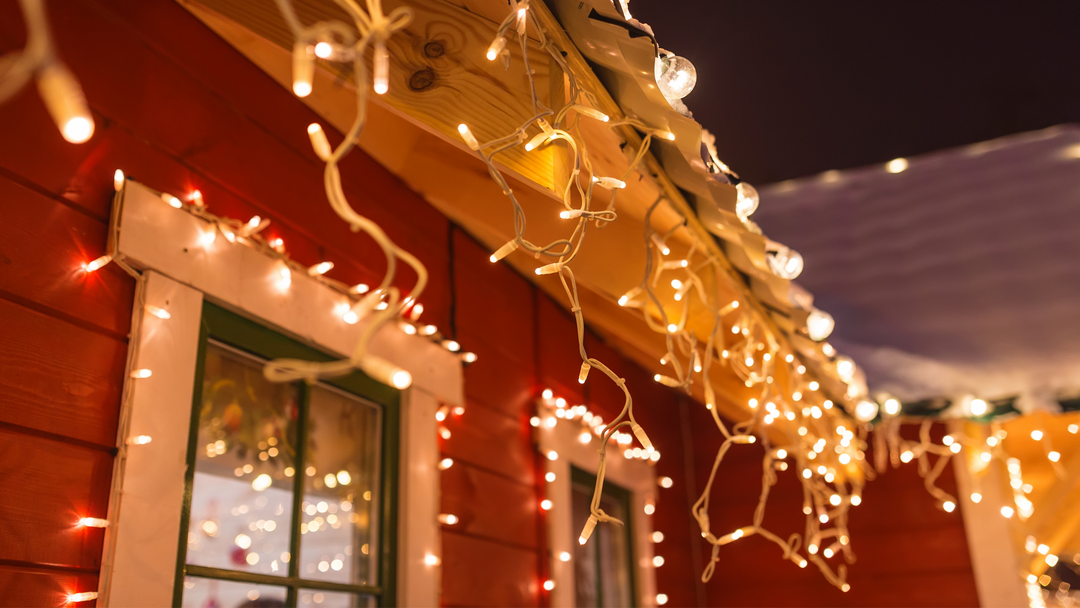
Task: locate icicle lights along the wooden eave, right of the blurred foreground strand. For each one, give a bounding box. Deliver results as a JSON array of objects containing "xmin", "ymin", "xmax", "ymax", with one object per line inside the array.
[{"xmin": 458, "ymin": 1, "xmax": 863, "ymax": 591}]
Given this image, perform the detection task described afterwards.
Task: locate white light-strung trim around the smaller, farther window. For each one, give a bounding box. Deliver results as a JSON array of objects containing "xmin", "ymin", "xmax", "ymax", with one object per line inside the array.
[{"xmin": 534, "ymin": 404, "xmax": 662, "ymax": 608}]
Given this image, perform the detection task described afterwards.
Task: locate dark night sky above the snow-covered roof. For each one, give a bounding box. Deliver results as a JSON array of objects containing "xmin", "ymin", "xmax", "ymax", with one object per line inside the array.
[{"xmin": 630, "ymin": 0, "xmax": 1080, "ymax": 185}]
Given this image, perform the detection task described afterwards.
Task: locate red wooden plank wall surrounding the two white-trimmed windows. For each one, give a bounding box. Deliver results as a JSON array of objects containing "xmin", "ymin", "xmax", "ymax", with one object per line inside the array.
[{"xmin": 0, "ymin": 0, "xmax": 974, "ymax": 606}]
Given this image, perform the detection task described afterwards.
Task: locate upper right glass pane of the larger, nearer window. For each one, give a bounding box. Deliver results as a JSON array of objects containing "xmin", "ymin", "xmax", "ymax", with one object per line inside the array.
[{"xmin": 300, "ymin": 384, "xmax": 380, "ymax": 584}]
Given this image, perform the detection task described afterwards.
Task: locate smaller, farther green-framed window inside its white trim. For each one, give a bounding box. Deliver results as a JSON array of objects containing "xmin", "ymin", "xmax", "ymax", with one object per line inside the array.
[{"xmin": 570, "ymin": 467, "xmax": 635, "ymax": 608}]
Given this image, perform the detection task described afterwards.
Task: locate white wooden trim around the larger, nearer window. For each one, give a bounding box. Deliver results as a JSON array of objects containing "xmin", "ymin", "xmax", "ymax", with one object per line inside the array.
[{"xmin": 99, "ymin": 180, "xmax": 464, "ymax": 607}]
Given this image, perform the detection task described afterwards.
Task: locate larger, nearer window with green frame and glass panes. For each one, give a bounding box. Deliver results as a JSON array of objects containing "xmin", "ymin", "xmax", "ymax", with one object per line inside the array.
[{"xmin": 173, "ymin": 302, "xmax": 401, "ymax": 608}]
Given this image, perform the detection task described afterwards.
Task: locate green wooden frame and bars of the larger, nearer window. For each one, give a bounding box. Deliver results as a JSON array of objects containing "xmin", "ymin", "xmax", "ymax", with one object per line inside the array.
[{"xmin": 173, "ymin": 301, "xmax": 401, "ymax": 606}]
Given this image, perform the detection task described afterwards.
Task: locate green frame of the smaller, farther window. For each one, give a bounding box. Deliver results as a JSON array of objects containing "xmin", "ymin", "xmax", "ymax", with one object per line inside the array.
[{"xmin": 570, "ymin": 465, "xmax": 638, "ymax": 608}]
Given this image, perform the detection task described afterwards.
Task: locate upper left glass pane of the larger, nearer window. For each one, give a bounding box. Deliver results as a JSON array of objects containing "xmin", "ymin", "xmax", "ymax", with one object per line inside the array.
[{"xmin": 187, "ymin": 343, "xmax": 299, "ymax": 578}]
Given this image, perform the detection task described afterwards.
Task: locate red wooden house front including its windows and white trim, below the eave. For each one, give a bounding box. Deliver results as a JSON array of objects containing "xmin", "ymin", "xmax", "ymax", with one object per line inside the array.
[{"xmin": 0, "ymin": 0, "xmax": 978, "ymax": 606}]
